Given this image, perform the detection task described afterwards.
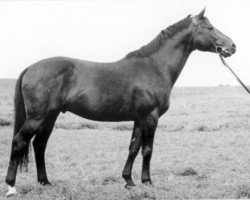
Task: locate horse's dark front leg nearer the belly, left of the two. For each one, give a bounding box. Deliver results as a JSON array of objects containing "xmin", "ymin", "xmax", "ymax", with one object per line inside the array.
[{"xmin": 122, "ymin": 122, "xmax": 141, "ymax": 188}]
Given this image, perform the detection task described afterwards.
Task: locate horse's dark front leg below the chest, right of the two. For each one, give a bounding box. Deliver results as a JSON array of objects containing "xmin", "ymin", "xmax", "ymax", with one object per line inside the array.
[{"xmin": 141, "ymin": 110, "xmax": 158, "ymax": 185}]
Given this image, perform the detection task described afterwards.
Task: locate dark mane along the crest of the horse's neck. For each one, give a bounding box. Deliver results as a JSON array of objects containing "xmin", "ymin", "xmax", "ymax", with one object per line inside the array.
[{"xmin": 126, "ymin": 15, "xmax": 191, "ymax": 58}]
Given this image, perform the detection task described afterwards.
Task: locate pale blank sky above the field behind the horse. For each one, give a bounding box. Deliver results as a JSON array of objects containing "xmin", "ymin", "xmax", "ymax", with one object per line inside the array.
[{"xmin": 0, "ymin": 0, "xmax": 250, "ymax": 86}]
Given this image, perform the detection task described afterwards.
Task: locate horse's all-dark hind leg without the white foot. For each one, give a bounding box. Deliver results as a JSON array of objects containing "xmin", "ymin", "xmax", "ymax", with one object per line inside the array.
[{"xmin": 33, "ymin": 112, "xmax": 59, "ymax": 185}]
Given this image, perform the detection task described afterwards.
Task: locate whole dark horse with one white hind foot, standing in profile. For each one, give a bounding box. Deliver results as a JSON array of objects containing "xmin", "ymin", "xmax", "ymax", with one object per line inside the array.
[{"xmin": 6, "ymin": 9, "xmax": 236, "ymax": 195}]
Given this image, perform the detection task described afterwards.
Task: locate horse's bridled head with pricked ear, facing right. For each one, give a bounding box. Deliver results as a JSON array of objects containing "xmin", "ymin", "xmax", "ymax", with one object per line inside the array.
[{"xmin": 192, "ymin": 9, "xmax": 236, "ymax": 57}]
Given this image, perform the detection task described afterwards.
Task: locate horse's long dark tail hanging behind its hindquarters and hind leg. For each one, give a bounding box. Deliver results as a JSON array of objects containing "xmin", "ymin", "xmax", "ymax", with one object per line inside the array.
[{"xmin": 13, "ymin": 68, "xmax": 30, "ymax": 170}]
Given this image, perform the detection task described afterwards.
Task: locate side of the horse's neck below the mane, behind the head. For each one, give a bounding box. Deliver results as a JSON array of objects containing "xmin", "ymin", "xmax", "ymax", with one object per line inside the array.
[{"xmin": 150, "ymin": 31, "xmax": 194, "ymax": 86}]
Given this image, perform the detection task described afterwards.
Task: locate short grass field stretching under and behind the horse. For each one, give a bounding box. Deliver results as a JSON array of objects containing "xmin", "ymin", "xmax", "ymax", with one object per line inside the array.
[{"xmin": 0, "ymin": 80, "xmax": 250, "ymax": 200}]
